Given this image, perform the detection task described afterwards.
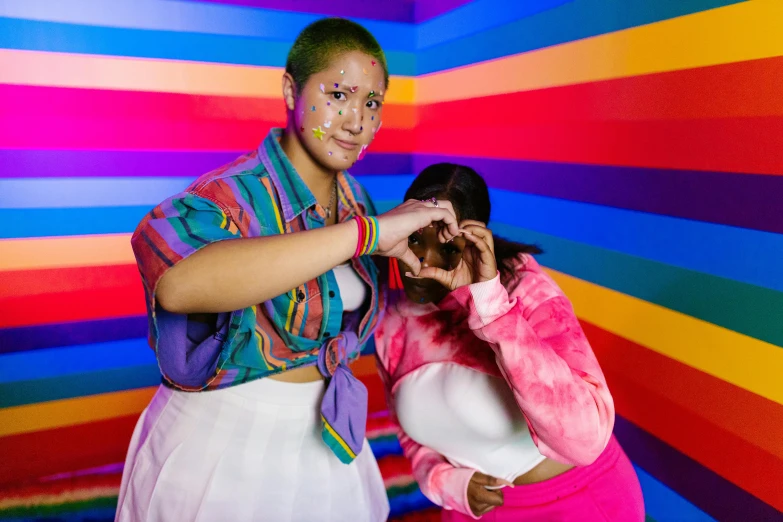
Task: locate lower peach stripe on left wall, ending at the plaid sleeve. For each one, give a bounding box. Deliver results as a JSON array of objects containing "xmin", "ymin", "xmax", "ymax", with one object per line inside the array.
[{"xmin": 0, "ymin": 234, "xmax": 136, "ymax": 270}]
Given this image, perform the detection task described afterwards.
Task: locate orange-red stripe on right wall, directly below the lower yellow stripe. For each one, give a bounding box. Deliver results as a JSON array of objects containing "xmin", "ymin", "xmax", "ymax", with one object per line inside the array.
[{"xmin": 582, "ymin": 322, "xmax": 783, "ymax": 459}]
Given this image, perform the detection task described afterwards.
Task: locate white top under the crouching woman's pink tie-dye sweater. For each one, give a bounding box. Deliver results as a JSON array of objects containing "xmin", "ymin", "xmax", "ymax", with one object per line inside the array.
[{"xmin": 394, "ymin": 363, "xmax": 545, "ymax": 481}]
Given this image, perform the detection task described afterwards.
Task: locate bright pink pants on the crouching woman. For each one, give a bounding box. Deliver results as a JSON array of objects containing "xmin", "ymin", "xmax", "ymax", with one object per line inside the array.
[{"xmin": 441, "ymin": 437, "xmax": 644, "ymax": 522}]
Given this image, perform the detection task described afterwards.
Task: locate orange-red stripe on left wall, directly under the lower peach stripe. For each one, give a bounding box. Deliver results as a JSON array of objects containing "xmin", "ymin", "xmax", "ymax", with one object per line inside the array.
[{"xmin": 0, "ymin": 264, "xmax": 141, "ymax": 298}]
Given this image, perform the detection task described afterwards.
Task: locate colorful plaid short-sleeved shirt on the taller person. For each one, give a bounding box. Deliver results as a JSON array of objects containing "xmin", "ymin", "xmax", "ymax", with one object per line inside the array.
[{"xmin": 131, "ymin": 129, "xmax": 382, "ymax": 391}]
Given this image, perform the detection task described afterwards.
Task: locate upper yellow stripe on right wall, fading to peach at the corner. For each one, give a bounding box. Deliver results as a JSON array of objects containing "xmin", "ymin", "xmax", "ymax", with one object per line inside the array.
[{"xmin": 416, "ymin": 0, "xmax": 783, "ymax": 104}]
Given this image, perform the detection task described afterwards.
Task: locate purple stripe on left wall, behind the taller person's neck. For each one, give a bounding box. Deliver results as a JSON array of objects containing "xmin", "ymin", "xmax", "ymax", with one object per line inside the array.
[{"xmin": 0, "ymin": 150, "xmax": 413, "ymax": 179}]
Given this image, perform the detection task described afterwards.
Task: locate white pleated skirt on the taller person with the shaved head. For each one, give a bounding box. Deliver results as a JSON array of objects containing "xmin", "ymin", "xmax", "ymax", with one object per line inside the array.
[{"xmin": 116, "ymin": 379, "xmax": 389, "ymax": 522}]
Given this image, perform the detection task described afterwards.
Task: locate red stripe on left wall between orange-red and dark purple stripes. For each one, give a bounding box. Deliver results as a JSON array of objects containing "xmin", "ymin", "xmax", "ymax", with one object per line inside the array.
[{"xmin": 0, "ymin": 281, "xmax": 147, "ymax": 328}]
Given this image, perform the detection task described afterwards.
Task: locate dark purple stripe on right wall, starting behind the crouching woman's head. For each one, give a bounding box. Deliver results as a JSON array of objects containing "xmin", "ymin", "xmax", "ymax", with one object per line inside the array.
[{"xmin": 413, "ymin": 155, "xmax": 783, "ymax": 233}]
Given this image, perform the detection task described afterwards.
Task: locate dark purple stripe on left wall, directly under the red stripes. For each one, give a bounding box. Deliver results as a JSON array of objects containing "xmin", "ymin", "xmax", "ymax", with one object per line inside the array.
[{"xmin": 0, "ymin": 315, "xmax": 147, "ymax": 354}]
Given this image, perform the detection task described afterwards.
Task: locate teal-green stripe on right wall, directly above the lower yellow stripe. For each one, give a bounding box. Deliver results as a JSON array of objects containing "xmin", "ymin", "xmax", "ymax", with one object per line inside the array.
[{"xmin": 491, "ymin": 223, "xmax": 783, "ymax": 347}]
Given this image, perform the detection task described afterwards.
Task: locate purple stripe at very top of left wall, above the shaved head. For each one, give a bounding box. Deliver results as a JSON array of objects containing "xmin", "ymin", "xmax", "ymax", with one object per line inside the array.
[{"xmin": 180, "ymin": 0, "xmax": 414, "ymax": 23}]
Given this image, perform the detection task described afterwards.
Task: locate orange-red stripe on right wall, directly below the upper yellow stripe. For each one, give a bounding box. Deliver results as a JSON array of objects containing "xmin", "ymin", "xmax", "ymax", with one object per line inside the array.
[{"xmin": 419, "ymin": 57, "xmax": 783, "ymax": 124}]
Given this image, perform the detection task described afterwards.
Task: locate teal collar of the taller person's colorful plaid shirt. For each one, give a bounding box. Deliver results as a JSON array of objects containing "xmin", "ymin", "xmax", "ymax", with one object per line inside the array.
[{"xmin": 258, "ymin": 128, "xmax": 365, "ymax": 223}]
